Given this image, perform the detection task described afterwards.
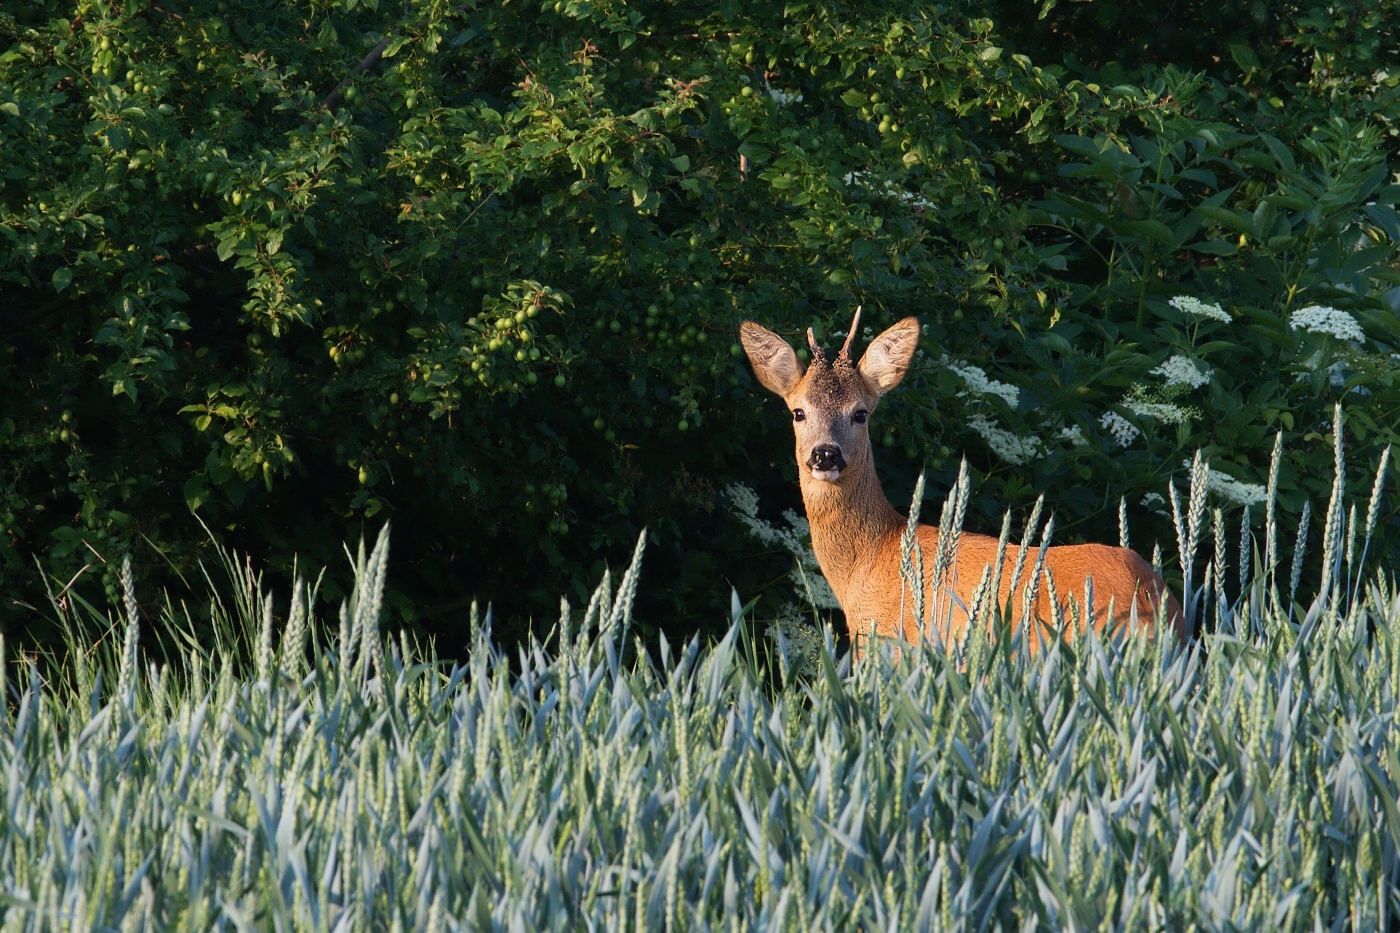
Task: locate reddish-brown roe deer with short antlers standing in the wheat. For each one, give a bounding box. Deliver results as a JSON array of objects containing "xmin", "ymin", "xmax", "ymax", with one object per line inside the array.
[{"xmin": 739, "ymin": 310, "xmax": 1183, "ymax": 647}]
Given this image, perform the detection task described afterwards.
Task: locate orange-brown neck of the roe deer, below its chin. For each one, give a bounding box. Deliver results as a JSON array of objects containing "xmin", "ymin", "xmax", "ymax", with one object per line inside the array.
[{"xmin": 798, "ymin": 451, "xmax": 904, "ymax": 607}]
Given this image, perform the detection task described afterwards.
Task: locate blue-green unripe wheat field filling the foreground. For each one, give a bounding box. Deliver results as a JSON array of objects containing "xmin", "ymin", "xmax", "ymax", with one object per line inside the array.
[{"xmin": 0, "ymin": 429, "xmax": 1400, "ymax": 933}]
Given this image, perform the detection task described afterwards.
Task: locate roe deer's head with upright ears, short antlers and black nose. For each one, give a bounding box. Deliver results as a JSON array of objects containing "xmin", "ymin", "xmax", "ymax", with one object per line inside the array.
[{"xmin": 739, "ymin": 308, "xmax": 918, "ymax": 490}]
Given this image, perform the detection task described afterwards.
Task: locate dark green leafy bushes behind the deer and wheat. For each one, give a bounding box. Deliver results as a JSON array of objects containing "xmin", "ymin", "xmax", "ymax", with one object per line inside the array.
[{"xmin": 0, "ymin": 0, "xmax": 1400, "ymax": 644}]
